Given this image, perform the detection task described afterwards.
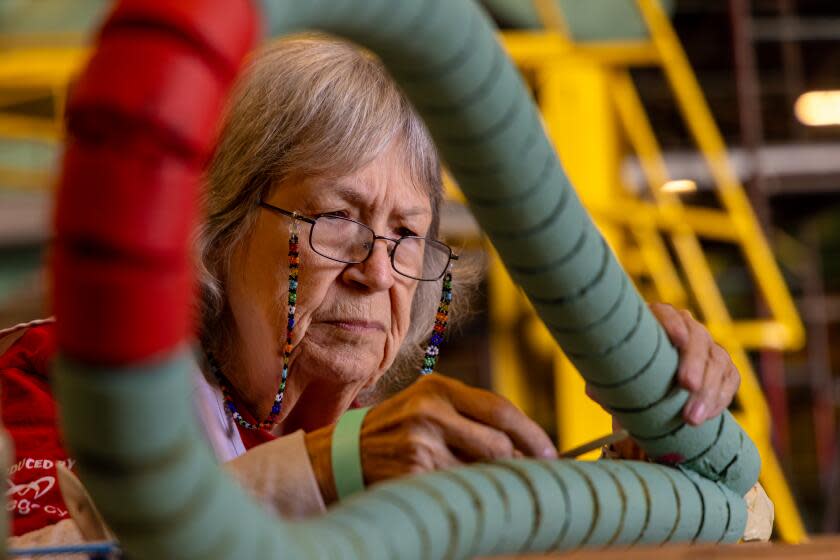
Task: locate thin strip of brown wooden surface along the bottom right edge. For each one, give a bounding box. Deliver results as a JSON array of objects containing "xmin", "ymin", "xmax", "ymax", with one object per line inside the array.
[{"xmin": 492, "ymin": 535, "xmax": 840, "ymax": 560}]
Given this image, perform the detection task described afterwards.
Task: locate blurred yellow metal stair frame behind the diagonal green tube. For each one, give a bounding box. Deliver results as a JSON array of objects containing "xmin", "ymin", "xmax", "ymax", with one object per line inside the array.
[{"xmin": 482, "ymin": 0, "xmax": 806, "ymax": 542}]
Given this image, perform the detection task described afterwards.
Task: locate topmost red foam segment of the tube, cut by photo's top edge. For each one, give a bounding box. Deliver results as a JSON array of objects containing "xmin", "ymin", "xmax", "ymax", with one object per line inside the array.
[{"xmin": 105, "ymin": 0, "xmax": 258, "ymax": 80}]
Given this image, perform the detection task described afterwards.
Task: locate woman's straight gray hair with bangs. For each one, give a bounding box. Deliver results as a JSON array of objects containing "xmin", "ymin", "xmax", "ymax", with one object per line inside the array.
[{"xmin": 196, "ymin": 35, "xmax": 460, "ymax": 390}]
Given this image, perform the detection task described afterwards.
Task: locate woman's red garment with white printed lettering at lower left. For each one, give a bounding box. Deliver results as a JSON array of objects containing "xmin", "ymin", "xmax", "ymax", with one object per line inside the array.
[{"xmin": 0, "ymin": 323, "xmax": 274, "ymax": 536}]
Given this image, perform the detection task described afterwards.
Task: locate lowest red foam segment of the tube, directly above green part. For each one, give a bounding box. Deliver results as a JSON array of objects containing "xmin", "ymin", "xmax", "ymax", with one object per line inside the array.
[{"xmin": 52, "ymin": 245, "xmax": 194, "ymax": 365}]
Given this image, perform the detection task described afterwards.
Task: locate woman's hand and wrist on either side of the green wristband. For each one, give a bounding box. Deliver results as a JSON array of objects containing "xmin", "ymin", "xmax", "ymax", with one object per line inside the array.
[{"xmin": 307, "ymin": 374, "xmax": 557, "ymax": 503}]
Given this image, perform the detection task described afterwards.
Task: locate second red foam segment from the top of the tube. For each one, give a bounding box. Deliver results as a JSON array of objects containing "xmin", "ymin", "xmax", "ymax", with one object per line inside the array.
[{"xmin": 68, "ymin": 29, "xmax": 227, "ymax": 160}]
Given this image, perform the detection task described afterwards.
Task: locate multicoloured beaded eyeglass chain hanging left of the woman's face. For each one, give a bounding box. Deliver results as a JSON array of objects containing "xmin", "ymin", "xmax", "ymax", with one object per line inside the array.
[{"xmin": 212, "ymin": 218, "xmax": 300, "ymax": 430}]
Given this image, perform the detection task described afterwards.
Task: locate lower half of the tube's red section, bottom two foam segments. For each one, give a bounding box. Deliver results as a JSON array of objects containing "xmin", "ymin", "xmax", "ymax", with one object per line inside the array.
[{"xmin": 52, "ymin": 142, "xmax": 200, "ymax": 363}]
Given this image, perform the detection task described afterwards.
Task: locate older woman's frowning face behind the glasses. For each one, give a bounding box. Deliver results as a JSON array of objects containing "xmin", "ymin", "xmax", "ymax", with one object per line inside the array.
[{"xmin": 226, "ymin": 143, "xmax": 432, "ymax": 417}]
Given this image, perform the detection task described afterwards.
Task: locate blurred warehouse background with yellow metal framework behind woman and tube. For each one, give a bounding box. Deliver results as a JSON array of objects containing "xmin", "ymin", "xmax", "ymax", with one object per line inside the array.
[{"xmin": 0, "ymin": 0, "xmax": 840, "ymax": 540}]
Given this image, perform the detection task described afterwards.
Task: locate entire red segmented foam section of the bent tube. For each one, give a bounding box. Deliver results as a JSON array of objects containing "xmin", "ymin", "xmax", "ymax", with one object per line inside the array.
[{"xmin": 52, "ymin": 0, "xmax": 257, "ymax": 365}]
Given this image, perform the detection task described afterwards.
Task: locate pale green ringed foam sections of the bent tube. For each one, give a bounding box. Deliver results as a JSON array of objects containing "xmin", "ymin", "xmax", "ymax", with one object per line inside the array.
[{"xmin": 55, "ymin": 0, "xmax": 759, "ymax": 558}]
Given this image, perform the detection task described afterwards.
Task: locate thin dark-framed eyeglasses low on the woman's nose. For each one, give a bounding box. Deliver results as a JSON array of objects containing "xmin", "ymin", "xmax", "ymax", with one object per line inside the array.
[{"xmin": 259, "ymin": 201, "xmax": 458, "ymax": 282}]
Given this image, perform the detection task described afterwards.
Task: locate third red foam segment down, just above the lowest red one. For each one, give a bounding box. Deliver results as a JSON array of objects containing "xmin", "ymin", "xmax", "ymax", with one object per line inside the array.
[{"xmin": 55, "ymin": 142, "xmax": 201, "ymax": 262}]
